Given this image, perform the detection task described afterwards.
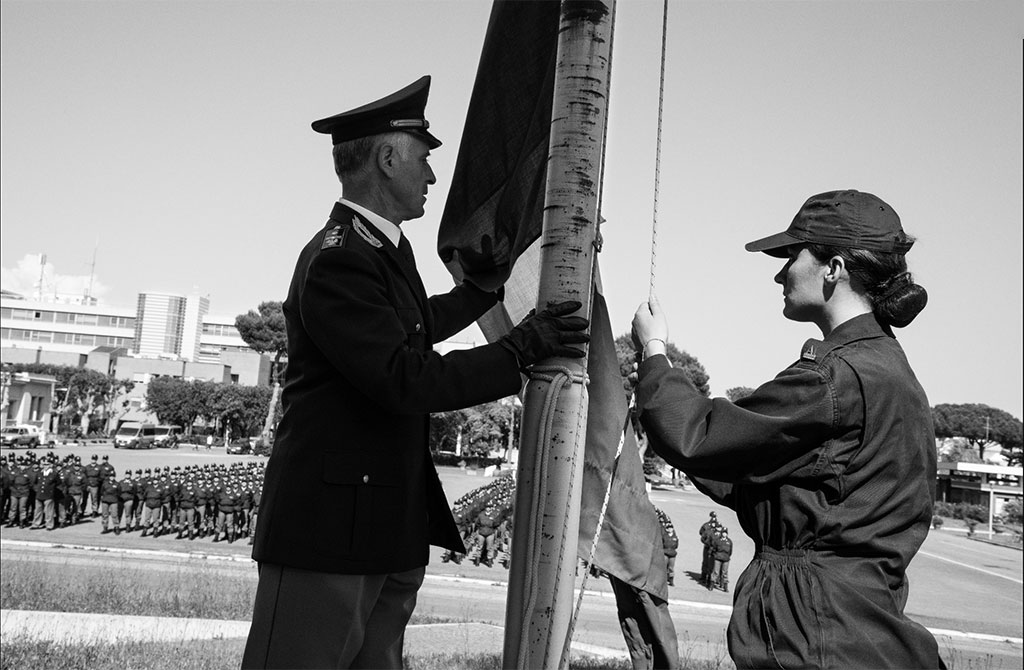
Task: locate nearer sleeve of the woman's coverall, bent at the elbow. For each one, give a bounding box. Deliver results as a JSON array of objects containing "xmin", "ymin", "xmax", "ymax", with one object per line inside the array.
[{"xmin": 637, "ymin": 355, "xmax": 838, "ymax": 485}]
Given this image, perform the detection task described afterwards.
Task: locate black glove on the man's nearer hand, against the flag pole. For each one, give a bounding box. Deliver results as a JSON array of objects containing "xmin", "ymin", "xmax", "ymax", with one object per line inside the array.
[{"xmin": 498, "ymin": 300, "xmax": 590, "ymax": 368}]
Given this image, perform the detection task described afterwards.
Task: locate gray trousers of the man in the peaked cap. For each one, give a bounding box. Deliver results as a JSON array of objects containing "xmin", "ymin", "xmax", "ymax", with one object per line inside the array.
[{"xmin": 242, "ymin": 563, "xmax": 426, "ymax": 670}]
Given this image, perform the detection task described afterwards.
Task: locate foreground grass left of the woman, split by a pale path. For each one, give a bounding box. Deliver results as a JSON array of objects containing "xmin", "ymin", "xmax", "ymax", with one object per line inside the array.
[{"xmin": 0, "ymin": 557, "xmax": 732, "ymax": 670}]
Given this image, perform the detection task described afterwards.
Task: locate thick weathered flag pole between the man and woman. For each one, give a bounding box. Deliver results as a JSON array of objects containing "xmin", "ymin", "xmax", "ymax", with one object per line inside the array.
[{"xmin": 503, "ymin": 0, "xmax": 614, "ymax": 669}]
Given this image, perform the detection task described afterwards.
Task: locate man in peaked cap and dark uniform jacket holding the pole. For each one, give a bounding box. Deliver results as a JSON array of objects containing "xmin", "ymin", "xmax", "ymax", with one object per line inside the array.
[{"xmin": 243, "ymin": 77, "xmax": 588, "ymax": 668}]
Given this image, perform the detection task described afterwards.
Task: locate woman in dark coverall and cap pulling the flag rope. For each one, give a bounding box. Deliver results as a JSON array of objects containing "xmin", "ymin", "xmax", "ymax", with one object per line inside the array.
[{"xmin": 633, "ymin": 191, "xmax": 944, "ymax": 669}]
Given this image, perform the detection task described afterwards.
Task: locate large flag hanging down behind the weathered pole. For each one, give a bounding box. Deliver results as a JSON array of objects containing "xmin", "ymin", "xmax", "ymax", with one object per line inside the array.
[{"xmin": 437, "ymin": 0, "xmax": 668, "ymax": 600}]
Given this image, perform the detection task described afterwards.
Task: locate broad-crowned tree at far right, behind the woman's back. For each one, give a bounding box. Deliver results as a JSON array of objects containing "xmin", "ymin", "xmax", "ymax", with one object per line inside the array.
[{"xmin": 932, "ymin": 404, "xmax": 1024, "ymax": 462}]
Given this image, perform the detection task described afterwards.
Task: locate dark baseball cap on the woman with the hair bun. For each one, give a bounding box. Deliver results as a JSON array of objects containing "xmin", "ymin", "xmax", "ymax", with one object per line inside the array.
[{"xmin": 745, "ymin": 190, "xmax": 913, "ymax": 258}]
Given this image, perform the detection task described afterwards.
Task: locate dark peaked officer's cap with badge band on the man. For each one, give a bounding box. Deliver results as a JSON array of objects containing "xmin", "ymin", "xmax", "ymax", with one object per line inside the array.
[{"xmin": 312, "ymin": 75, "xmax": 441, "ymax": 149}]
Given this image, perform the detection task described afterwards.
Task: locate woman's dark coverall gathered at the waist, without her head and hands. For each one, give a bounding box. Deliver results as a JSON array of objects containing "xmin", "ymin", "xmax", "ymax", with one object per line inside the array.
[{"xmin": 637, "ymin": 315, "xmax": 938, "ymax": 668}]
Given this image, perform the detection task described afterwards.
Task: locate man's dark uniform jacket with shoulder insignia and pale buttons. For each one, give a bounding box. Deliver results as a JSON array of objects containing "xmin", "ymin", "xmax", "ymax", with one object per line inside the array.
[{"xmin": 253, "ymin": 203, "xmax": 521, "ymax": 574}]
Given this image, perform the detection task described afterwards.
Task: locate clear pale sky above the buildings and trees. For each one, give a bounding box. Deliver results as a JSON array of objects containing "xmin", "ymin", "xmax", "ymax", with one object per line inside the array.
[{"xmin": 0, "ymin": 0, "xmax": 1024, "ymax": 417}]
